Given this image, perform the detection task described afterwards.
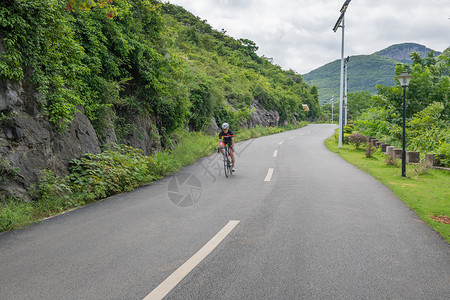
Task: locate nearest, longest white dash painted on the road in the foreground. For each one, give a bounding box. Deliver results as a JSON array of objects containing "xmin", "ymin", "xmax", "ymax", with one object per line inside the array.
[{"xmin": 143, "ymin": 221, "xmax": 240, "ymax": 300}]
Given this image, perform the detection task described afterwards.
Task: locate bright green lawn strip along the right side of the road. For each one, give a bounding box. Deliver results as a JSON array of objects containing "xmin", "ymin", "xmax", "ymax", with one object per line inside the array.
[{"xmin": 325, "ymin": 137, "xmax": 450, "ymax": 243}]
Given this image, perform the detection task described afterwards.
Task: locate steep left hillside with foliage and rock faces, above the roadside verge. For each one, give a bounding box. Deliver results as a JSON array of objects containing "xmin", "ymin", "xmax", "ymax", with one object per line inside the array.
[{"xmin": 0, "ymin": 0, "xmax": 321, "ymax": 202}]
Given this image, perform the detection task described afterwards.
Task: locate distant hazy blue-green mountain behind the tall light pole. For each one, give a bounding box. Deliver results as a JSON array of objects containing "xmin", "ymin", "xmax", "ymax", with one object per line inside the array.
[{"xmin": 302, "ymin": 43, "xmax": 440, "ymax": 104}]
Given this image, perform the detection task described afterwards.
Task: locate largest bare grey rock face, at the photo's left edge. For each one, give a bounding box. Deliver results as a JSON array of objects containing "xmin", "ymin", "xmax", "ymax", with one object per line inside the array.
[{"xmin": 0, "ymin": 78, "xmax": 100, "ymax": 198}]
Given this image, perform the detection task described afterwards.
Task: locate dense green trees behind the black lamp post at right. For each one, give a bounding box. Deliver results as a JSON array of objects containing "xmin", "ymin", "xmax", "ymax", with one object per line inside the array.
[{"xmin": 356, "ymin": 48, "xmax": 450, "ymax": 162}]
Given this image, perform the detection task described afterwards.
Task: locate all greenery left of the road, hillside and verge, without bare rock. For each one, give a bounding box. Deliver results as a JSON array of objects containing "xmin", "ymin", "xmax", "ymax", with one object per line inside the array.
[{"xmin": 0, "ymin": 0, "xmax": 321, "ymax": 230}]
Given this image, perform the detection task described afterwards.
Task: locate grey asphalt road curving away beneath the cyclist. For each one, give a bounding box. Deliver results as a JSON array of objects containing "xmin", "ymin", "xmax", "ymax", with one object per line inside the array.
[{"xmin": 0, "ymin": 125, "xmax": 450, "ymax": 300}]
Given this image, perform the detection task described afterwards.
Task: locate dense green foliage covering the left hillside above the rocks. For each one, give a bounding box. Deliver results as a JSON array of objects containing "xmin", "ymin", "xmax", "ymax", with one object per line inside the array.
[{"xmin": 0, "ymin": 0, "xmax": 321, "ymax": 143}]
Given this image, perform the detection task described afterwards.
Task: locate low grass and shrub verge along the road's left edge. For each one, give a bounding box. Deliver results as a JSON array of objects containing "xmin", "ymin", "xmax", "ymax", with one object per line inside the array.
[{"xmin": 0, "ymin": 123, "xmax": 307, "ymax": 232}]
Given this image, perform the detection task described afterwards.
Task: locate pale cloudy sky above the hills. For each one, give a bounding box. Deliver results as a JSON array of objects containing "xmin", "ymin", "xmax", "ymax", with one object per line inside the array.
[{"xmin": 166, "ymin": 0, "xmax": 450, "ymax": 74}]
